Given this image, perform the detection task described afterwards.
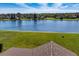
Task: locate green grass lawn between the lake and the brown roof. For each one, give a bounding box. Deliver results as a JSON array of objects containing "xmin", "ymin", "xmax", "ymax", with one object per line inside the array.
[{"xmin": 0, "ymin": 31, "xmax": 79, "ymax": 55}]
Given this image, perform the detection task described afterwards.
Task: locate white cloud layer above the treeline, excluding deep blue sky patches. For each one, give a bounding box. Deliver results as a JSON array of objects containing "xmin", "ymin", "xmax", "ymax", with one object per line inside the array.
[{"xmin": 0, "ymin": 3, "xmax": 79, "ymax": 13}]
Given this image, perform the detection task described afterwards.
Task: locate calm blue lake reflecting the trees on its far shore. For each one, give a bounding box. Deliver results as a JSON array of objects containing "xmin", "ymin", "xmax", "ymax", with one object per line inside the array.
[{"xmin": 0, "ymin": 20, "xmax": 79, "ymax": 32}]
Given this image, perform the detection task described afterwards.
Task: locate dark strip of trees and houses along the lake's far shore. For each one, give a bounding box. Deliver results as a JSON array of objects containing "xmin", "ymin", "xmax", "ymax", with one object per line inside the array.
[{"xmin": 0, "ymin": 13, "xmax": 79, "ymax": 20}]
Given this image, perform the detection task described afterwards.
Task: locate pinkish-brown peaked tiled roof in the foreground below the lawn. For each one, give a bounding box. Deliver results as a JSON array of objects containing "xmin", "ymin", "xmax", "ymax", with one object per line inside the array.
[{"xmin": 0, "ymin": 41, "xmax": 77, "ymax": 56}]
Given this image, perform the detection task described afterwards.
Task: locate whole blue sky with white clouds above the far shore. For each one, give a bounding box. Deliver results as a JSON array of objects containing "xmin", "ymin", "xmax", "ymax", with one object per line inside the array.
[{"xmin": 0, "ymin": 3, "xmax": 79, "ymax": 14}]
